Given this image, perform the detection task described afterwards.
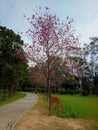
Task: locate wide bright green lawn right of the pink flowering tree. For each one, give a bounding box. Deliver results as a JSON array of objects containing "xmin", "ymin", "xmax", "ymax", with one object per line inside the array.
[{"xmin": 57, "ymin": 95, "xmax": 98, "ymax": 120}]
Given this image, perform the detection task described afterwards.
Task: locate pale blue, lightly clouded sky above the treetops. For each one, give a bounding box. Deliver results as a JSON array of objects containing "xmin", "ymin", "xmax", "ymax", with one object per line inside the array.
[{"xmin": 0, "ymin": 0, "xmax": 98, "ymax": 44}]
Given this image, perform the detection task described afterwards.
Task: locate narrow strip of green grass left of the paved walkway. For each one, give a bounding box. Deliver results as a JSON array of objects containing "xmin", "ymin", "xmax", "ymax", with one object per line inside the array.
[{"xmin": 0, "ymin": 92, "xmax": 25, "ymax": 106}]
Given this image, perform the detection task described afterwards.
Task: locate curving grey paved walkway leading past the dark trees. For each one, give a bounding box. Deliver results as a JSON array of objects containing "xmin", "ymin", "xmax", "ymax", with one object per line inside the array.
[{"xmin": 0, "ymin": 93, "xmax": 38, "ymax": 130}]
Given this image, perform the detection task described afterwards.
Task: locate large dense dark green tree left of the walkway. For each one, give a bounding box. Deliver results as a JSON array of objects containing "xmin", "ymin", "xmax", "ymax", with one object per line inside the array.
[{"xmin": 0, "ymin": 26, "xmax": 27, "ymax": 100}]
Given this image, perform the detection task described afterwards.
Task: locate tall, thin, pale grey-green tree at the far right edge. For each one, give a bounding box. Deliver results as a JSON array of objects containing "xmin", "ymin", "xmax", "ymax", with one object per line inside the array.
[{"xmin": 85, "ymin": 37, "xmax": 98, "ymax": 93}]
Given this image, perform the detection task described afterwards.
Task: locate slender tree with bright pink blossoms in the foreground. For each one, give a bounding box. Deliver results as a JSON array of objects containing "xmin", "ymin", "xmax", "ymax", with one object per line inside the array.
[{"xmin": 24, "ymin": 7, "xmax": 78, "ymax": 115}]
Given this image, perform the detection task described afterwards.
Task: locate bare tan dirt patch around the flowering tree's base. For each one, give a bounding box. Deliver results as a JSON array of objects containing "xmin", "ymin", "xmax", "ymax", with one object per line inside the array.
[{"xmin": 14, "ymin": 108, "xmax": 93, "ymax": 130}]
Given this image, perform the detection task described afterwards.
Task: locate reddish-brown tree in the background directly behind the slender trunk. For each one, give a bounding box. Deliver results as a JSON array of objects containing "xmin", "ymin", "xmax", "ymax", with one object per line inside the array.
[{"xmin": 29, "ymin": 57, "xmax": 62, "ymax": 92}]
